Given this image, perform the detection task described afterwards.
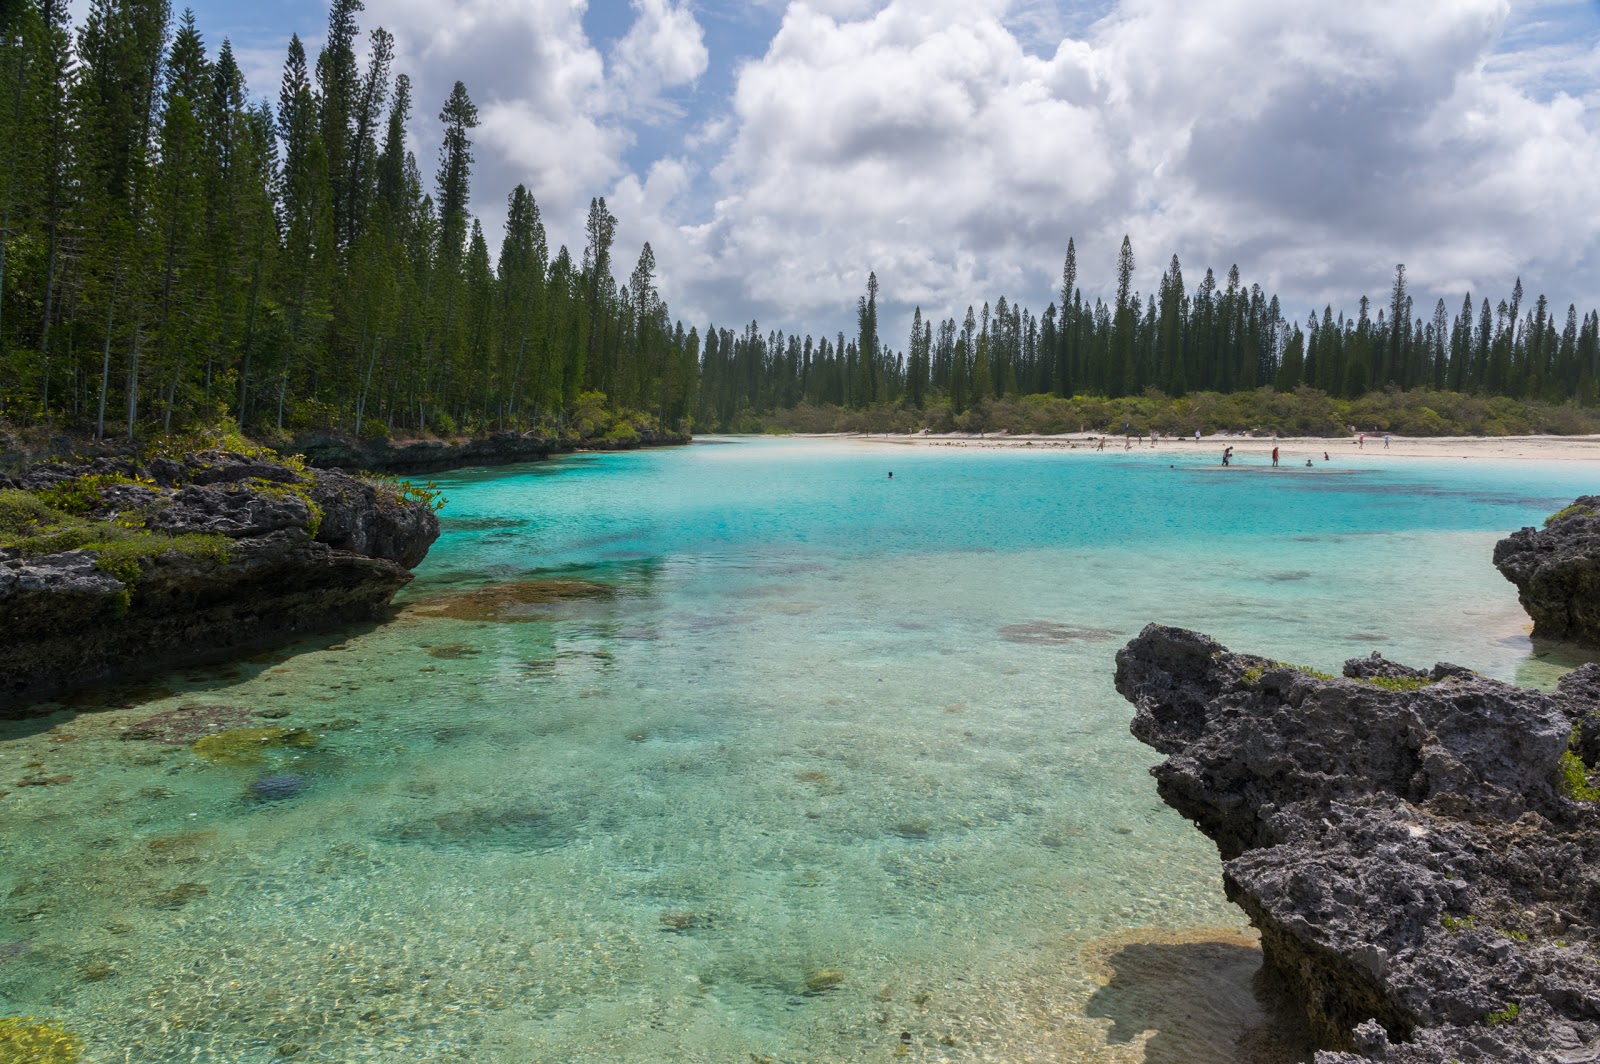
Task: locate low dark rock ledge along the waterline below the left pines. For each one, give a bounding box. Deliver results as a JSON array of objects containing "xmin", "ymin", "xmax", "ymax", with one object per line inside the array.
[{"xmin": 291, "ymin": 430, "xmax": 690, "ymax": 474}]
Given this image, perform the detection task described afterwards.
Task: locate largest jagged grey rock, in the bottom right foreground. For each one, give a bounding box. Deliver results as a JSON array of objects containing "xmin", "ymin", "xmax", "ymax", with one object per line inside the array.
[{"xmin": 1117, "ymin": 626, "xmax": 1600, "ymax": 1064}]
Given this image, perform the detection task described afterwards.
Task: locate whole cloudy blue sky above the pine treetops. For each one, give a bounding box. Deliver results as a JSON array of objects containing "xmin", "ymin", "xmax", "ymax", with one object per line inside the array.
[{"xmin": 128, "ymin": 0, "xmax": 1600, "ymax": 347}]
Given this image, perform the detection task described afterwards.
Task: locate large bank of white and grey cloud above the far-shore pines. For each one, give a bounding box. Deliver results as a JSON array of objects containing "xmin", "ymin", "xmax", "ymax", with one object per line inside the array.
[{"xmin": 624, "ymin": 0, "xmax": 1600, "ymax": 340}]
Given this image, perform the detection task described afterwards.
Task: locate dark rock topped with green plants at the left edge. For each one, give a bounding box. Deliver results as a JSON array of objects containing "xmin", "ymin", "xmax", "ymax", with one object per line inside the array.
[{"xmin": 0, "ymin": 451, "xmax": 438, "ymax": 707}]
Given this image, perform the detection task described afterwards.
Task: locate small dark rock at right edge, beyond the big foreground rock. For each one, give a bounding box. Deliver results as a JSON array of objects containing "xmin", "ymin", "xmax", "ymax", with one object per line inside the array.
[{"xmin": 1494, "ymin": 494, "xmax": 1600, "ymax": 646}]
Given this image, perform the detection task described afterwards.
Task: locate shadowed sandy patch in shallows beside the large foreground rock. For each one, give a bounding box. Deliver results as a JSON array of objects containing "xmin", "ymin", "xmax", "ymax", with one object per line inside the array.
[{"xmin": 1085, "ymin": 936, "xmax": 1314, "ymax": 1064}]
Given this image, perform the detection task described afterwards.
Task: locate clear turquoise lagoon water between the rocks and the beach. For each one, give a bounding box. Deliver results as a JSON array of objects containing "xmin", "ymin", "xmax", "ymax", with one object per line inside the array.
[{"xmin": 0, "ymin": 440, "xmax": 1594, "ymax": 1062}]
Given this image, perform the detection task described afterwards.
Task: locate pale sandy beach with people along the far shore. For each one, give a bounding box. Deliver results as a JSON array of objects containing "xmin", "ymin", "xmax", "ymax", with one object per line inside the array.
[{"xmin": 805, "ymin": 432, "xmax": 1600, "ymax": 467}]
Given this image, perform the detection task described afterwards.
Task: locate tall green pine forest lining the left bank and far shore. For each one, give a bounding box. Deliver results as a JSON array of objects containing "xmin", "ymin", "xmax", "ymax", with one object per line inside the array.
[{"xmin": 0, "ymin": 0, "xmax": 1600, "ymax": 437}]
